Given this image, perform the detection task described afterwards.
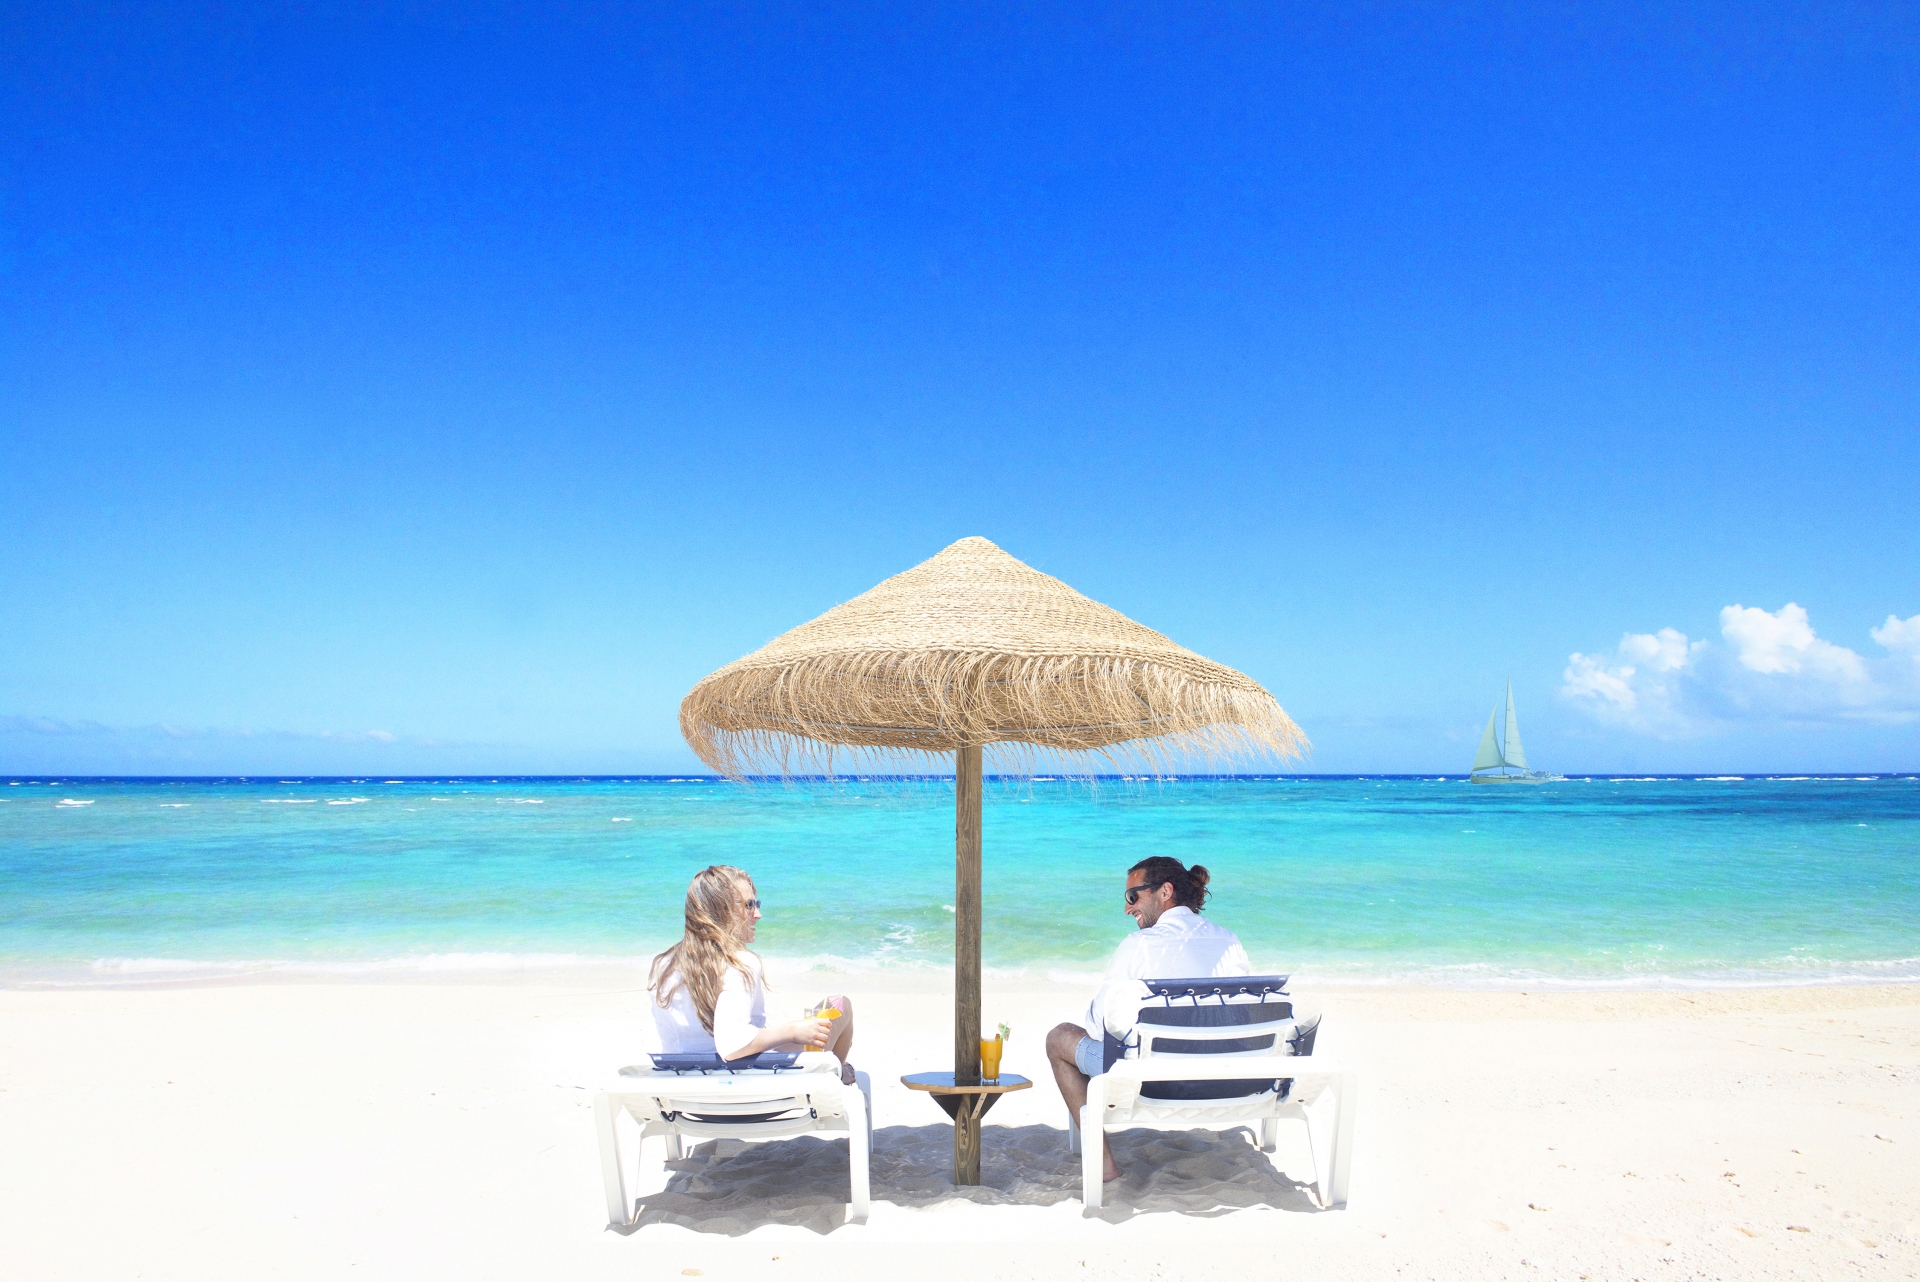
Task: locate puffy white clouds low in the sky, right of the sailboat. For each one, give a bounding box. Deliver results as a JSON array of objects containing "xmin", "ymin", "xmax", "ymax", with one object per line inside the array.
[{"xmin": 1561, "ymin": 601, "xmax": 1920, "ymax": 737}]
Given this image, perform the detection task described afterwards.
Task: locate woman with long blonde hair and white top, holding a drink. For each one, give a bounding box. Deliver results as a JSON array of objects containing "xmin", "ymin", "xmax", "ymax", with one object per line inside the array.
[{"xmin": 647, "ymin": 864, "xmax": 852, "ymax": 1084}]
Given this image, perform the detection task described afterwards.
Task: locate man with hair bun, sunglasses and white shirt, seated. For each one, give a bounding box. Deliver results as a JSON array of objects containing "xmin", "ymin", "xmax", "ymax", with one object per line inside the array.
[{"xmin": 1046, "ymin": 854, "xmax": 1319, "ymax": 1180}]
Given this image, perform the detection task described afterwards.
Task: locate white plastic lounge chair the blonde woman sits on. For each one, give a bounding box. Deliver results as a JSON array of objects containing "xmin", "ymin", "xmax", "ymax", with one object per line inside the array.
[{"xmin": 593, "ymin": 1052, "xmax": 874, "ymax": 1228}]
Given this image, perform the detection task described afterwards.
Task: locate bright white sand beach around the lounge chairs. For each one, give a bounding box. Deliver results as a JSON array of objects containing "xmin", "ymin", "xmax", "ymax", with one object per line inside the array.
[{"xmin": 0, "ymin": 971, "xmax": 1920, "ymax": 1282}]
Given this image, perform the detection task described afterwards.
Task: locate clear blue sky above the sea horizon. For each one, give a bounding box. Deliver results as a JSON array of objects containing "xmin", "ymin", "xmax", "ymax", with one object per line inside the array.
[{"xmin": 0, "ymin": 4, "xmax": 1920, "ymax": 773}]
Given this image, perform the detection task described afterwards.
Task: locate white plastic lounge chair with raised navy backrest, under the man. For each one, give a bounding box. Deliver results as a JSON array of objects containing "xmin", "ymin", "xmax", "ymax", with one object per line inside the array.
[{"xmin": 1068, "ymin": 975, "xmax": 1359, "ymax": 1213}]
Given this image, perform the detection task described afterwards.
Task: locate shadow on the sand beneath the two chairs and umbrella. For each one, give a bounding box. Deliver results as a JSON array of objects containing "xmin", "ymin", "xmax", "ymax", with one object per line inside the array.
[{"xmin": 624, "ymin": 1125, "xmax": 1319, "ymax": 1236}]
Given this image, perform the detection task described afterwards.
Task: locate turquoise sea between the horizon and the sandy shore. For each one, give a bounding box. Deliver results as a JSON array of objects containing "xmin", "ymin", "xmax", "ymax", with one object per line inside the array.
[{"xmin": 0, "ymin": 775, "xmax": 1920, "ymax": 986}]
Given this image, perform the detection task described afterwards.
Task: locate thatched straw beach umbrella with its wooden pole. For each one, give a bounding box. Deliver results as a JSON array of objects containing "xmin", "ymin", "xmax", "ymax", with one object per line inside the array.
[{"xmin": 680, "ymin": 537, "xmax": 1306, "ymax": 1166}]
